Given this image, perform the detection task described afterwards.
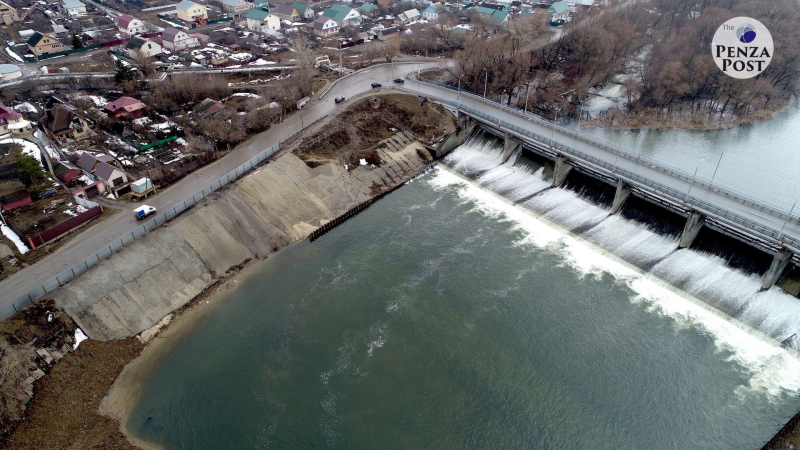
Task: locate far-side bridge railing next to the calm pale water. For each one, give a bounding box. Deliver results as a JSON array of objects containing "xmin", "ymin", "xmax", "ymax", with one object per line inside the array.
[{"xmin": 409, "ymin": 74, "xmax": 800, "ymax": 223}]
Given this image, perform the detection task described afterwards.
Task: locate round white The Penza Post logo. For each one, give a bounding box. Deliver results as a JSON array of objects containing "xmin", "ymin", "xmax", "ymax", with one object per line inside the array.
[{"xmin": 711, "ymin": 17, "xmax": 775, "ymax": 79}]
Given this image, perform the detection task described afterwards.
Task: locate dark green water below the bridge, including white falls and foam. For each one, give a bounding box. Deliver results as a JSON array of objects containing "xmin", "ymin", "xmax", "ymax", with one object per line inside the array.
[{"xmin": 129, "ymin": 137, "xmax": 800, "ymax": 449}]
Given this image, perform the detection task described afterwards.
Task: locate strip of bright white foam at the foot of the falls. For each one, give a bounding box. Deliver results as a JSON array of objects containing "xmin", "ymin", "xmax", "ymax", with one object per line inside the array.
[{"xmin": 428, "ymin": 167, "xmax": 800, "ymax": 396}]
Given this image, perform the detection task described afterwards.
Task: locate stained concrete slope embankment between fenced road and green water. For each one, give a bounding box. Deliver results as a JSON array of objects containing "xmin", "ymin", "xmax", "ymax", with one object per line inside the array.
[{"xmin": 52, "ymin": 137, "xmax": 428, "ymax": 340}]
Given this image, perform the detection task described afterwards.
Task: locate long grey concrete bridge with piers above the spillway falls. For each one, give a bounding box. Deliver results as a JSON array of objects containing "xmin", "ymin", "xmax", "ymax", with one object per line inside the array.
[{"xmin": 399, "ymin": 75, "xmax": 800, "ymax": 290}]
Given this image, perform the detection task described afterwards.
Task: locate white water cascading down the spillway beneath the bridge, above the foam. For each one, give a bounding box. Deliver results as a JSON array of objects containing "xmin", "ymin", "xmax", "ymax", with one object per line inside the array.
[{"xmin": 445, "ymin": 134, "xmax": 800, "ymax": 349}]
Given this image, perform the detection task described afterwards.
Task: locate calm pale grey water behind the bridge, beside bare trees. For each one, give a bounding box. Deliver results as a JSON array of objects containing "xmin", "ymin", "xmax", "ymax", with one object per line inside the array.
[{"xmin": 572, "ymin": 102, "xmax": 800, "ymax": 209}]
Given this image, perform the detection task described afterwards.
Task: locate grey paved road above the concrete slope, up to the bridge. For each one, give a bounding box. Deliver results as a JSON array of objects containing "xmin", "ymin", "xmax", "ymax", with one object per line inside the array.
[{"xmin": 0, "ymin": 62, "xmax": 438, "ymax": 310}]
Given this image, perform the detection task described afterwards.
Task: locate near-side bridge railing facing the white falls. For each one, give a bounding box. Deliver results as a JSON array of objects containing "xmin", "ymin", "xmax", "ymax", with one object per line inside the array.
[{"xmin": 416, "ymin": 96, "xmax": 800, "ymax": 249}]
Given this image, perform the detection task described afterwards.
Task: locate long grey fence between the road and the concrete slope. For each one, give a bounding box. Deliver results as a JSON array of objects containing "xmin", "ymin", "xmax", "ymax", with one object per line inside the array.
[{"xmin": 0, "ymin": 141, "xmax": 285, "ymax": 319}]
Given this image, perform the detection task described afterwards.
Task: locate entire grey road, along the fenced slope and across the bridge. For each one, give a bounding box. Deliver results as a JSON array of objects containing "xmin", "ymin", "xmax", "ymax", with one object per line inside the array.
[{"xmin": 0, "ymin": 62, "xmax": 800, "ymax": 309}]
